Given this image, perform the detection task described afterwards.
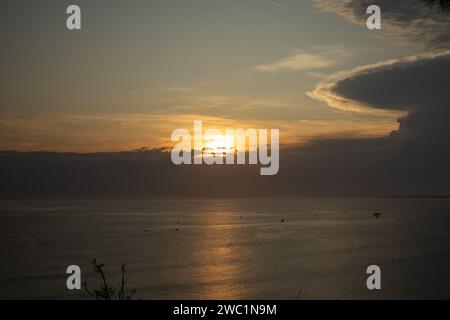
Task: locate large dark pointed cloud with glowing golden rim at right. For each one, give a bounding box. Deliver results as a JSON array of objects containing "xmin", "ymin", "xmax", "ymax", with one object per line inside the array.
[{"xmin": 308, "ymin": 51, "xmax": 450, "ymax": 143}]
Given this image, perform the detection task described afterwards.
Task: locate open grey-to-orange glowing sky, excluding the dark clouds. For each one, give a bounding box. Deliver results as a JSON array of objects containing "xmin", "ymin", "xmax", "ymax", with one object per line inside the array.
[{"xmin": 0, "ymin": 0, "xmax": 424, "ymax": 152}]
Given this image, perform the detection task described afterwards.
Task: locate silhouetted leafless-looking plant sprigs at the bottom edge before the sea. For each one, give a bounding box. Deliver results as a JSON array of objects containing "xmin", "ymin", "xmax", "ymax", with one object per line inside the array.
[{"xmin": 83, "ymin": 258, "xmax": 136, "ymax": 300}]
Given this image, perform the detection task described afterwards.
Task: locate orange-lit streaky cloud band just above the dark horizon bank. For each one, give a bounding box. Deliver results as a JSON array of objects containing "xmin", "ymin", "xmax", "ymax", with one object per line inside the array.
[{"xmin": 0, "ymin": 113, "xmax": 398, "ymax": 152}]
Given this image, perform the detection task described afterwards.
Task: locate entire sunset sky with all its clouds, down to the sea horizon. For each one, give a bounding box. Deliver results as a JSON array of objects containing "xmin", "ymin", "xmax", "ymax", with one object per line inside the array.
[{"xmin": 0, "ymin": 0, "xmax": 450, "ymax": 198}]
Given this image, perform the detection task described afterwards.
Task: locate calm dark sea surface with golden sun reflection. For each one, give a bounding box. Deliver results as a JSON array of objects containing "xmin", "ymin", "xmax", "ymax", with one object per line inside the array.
[{"xmin": 0, "ymin": 199, "xmax": 450, "ymax": 299}]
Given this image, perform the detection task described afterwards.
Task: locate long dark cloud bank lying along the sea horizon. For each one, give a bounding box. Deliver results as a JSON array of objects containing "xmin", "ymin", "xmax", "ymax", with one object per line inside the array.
[{"xmin": 0, "ymin": 129, "xmax": 450, "ymax": 199}]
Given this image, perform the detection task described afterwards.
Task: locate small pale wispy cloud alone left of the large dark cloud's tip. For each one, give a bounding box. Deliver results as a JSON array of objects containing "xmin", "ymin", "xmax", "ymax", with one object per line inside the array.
[{"xmin": 255, "ymin": 46, "xmax": 348, "ymax": 72}]
